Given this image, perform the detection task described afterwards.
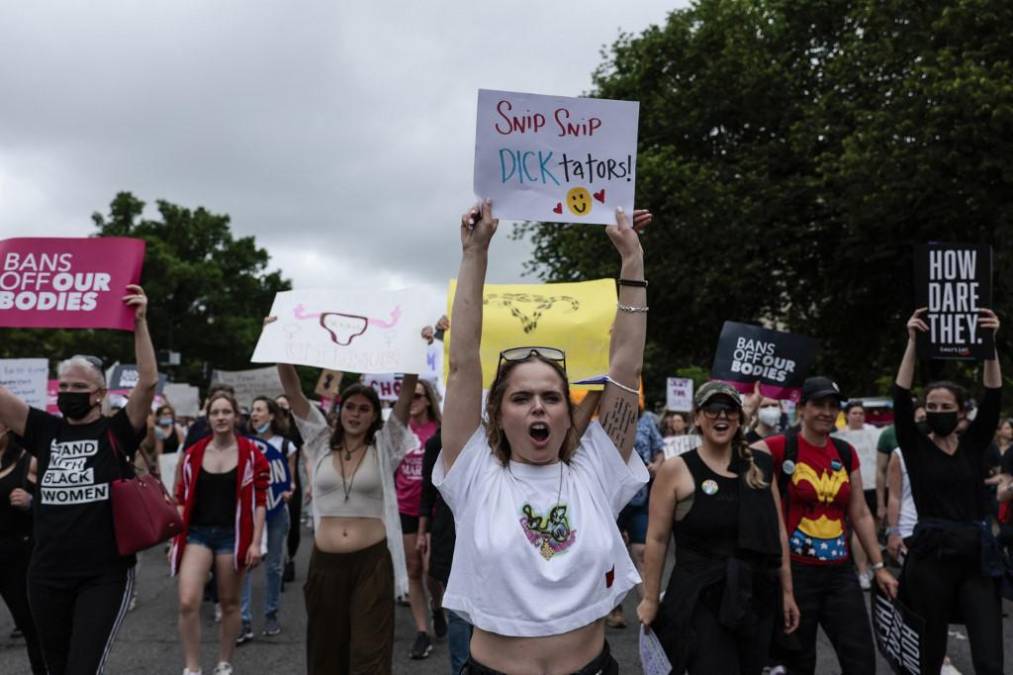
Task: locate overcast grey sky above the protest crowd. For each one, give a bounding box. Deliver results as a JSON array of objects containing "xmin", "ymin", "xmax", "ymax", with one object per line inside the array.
[{"xmin": 0, "ymin": 0, "xmax": 686, "ymax": 300}]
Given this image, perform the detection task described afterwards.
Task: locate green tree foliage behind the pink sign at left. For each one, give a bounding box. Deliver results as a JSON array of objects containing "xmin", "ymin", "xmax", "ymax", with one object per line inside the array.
[{"xmin": 0, "ymin": 193, "xmax": 291, "ymax": 383}]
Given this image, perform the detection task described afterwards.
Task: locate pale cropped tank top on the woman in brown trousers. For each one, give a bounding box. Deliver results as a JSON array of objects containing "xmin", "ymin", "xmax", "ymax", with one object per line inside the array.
[{"xmin": 313, "ymin": 445, "xmax": 384, "ymax": 520}]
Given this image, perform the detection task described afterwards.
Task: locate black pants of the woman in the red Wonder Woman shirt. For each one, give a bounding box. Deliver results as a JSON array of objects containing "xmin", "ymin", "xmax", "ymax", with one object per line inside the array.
[{"xmin": 785, "ymin": 563, "xmax": 875, "ymax": 675}]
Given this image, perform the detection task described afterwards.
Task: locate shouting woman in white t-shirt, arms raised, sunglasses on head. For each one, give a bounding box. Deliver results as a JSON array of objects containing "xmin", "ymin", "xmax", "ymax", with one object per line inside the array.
[{"xmin": 433, "ymin": 201, "xmax": 651, "ymax": 674}]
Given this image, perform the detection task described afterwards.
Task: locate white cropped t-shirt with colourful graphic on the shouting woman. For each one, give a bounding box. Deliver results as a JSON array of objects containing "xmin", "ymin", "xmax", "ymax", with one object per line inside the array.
[{"xmin": 433, "ymin": 422, "xmax": 648, "ymax": 636}]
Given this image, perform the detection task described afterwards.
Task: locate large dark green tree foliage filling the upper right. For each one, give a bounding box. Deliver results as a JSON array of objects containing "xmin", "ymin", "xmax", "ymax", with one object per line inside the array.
[{"xmin": 521, "ymin": 0, "xmax": 1013, "ymax": 398}]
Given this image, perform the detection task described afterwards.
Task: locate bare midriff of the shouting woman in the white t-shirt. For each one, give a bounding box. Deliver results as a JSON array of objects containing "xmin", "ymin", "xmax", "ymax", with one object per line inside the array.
[{"xmin": 471, "ymin": 619, "xmax": 605, "ymax": 675}]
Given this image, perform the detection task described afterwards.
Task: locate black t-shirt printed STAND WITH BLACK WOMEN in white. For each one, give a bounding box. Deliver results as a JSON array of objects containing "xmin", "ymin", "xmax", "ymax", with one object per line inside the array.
[{"xmin": 23, "ymin": 408, "xmax": 144, "ymax": 579}]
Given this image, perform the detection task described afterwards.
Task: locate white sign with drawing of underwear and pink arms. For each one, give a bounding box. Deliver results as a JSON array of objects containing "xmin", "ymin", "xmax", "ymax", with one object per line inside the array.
[{"xmin": 250, "ymin": 288, "xmax": 442, "ymax": 373}]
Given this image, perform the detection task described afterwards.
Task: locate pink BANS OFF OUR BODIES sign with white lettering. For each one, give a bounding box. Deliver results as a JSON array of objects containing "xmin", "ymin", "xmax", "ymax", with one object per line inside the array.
[{"xmin": 0, "ymin": 237, "xmax": 145, "ymax": 330}]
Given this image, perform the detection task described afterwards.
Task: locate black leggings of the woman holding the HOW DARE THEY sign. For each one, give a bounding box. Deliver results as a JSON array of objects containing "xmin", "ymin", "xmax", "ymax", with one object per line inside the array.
[{"xmin": 901, "ymin": 555, "xmax": 1003, "ymax": 675}]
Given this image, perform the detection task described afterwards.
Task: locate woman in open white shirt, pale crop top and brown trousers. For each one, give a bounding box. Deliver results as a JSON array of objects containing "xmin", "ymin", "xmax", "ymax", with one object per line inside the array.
[{"xmin": 267, "ymin": 354, "xmax": 418, "ymax": 675}]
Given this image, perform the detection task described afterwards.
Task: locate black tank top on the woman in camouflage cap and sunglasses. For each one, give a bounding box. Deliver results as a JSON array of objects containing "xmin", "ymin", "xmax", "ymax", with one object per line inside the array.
[{"xmin": 673, "ymin": 450, "xmax": 741, "ymax": 558}]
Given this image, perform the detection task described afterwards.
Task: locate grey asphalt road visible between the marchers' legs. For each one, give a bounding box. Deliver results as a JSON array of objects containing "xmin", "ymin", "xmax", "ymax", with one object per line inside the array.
[{"xmin": 0, "ymin": 531, "xmax": 1013, "ymax": 675}]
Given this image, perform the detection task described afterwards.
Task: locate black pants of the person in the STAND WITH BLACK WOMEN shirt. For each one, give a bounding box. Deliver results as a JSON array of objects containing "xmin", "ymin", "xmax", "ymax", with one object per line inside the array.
[{"xmin": 28, "ymin": 568, "xmax": 134, "ymax": 675}]
